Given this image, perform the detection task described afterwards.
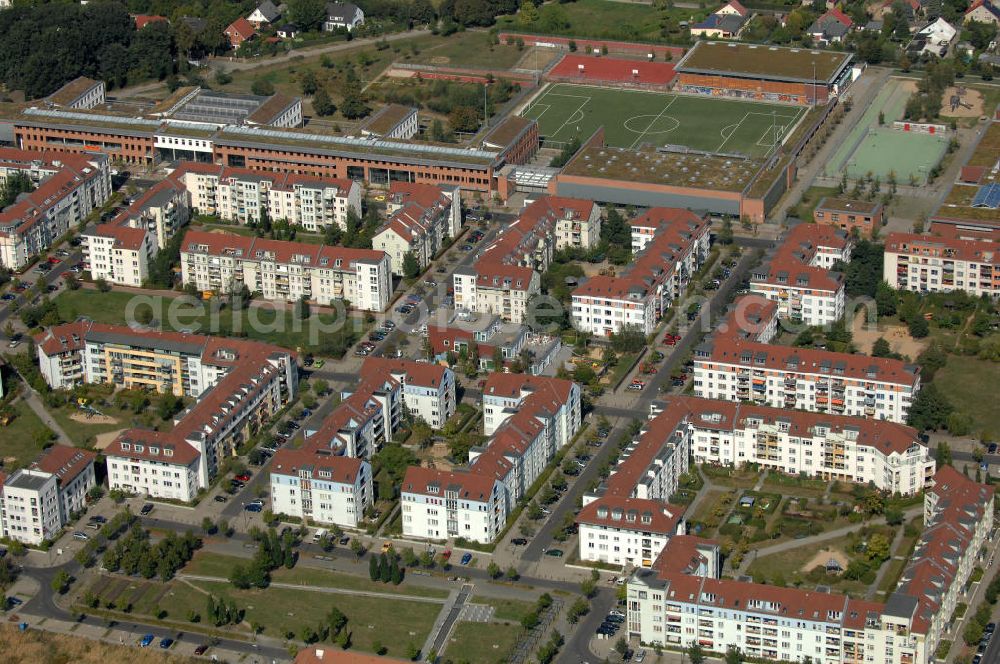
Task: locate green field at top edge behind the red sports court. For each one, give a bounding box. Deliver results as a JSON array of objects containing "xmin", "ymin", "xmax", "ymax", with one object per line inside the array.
[{"xmin": 497, "ymin": 0, "xmax": 708, "ymax": 42}]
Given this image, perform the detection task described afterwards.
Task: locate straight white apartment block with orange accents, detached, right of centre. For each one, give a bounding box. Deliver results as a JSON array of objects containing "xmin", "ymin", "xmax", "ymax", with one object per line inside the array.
[{"xmin": 694, "ymin": 337, "xmax": 920, "ymax": 422}]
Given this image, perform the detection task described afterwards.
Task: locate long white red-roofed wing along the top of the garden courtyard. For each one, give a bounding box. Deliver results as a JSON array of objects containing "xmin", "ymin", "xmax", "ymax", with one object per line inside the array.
[{"xmin": 679, "ymin": 398, "xmax": 935, "ymax": 495}]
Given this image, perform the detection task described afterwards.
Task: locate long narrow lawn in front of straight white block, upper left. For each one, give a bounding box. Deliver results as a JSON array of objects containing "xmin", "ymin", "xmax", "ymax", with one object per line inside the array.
[{"xmin": 54, "ymin": 289, "xmax": 363, "ymax": 356}]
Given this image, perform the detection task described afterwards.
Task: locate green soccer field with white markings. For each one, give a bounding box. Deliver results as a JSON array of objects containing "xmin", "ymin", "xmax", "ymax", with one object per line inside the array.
[{"xmin": 521, "ymin": 83, "xmax": 805, "ymax": 157}]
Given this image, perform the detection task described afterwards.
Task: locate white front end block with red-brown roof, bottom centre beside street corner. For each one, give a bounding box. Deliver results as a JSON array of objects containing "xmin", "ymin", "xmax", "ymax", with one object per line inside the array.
[{"xmin": 400, "ymin": 466, "xmax": 509, "ymax": 544}]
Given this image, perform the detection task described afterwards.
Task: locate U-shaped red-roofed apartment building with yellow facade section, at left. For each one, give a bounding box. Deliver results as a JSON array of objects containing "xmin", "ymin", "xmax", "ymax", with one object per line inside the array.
[{"xmin": 35, "ymin": 321, "xmax": 298, "ymax": 501}]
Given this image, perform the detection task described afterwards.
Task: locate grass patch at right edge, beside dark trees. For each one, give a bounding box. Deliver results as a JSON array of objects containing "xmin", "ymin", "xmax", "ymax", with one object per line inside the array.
[{"xmin": 934, "ymin": 355, "xmax": 1000, "ymax": 440}]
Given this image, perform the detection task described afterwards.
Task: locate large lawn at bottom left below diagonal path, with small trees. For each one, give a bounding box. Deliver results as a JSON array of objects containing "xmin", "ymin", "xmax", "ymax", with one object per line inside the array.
[{"xmin": 197, "ymin": 583, "xmax": 442, "ymax": 656}]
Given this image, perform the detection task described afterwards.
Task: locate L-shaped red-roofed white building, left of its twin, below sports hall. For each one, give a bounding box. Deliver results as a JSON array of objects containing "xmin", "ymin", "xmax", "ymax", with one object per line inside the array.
[{"xmin": 452, "ymin": 196, "xmax": 601, "ymax": 323}]
